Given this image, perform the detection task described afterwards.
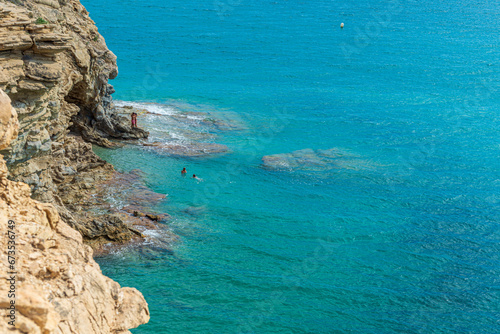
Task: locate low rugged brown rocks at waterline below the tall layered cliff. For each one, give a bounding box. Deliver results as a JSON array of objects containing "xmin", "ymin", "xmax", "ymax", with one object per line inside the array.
[{"xmin": 47, "ymin": 135, "xmax": 172, "ymax": 251}]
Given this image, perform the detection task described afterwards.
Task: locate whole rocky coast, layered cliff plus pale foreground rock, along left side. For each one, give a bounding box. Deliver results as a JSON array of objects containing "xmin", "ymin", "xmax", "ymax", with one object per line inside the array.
[{"xmin": 0, "ymin": 0, "xmax": 162, "ymax": 334}]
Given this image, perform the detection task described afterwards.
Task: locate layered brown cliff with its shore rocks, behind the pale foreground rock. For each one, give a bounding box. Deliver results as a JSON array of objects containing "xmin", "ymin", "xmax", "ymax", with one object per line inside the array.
[{"xmin": 0, "ymin": 0, "xmax": 156, "ymax": 247}]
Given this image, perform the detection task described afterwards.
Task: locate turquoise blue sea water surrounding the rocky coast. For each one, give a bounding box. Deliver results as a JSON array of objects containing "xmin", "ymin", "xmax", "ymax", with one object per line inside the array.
[{"xmin": 83, "ymin": 0, "xmax": 500, "ymax": 333}]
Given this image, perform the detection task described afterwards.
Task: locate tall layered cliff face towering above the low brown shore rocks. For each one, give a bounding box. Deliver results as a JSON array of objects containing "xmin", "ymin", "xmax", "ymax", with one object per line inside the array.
[{"xmin": 0, "ymin": 0, "xmax": 147, "ymax": 202}]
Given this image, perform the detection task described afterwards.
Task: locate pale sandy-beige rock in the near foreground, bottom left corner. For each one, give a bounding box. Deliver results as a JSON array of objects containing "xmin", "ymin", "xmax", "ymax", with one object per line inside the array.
[{"xmin": 0, "ymin": 90, "xmax": 149, "ymax": 334}]
